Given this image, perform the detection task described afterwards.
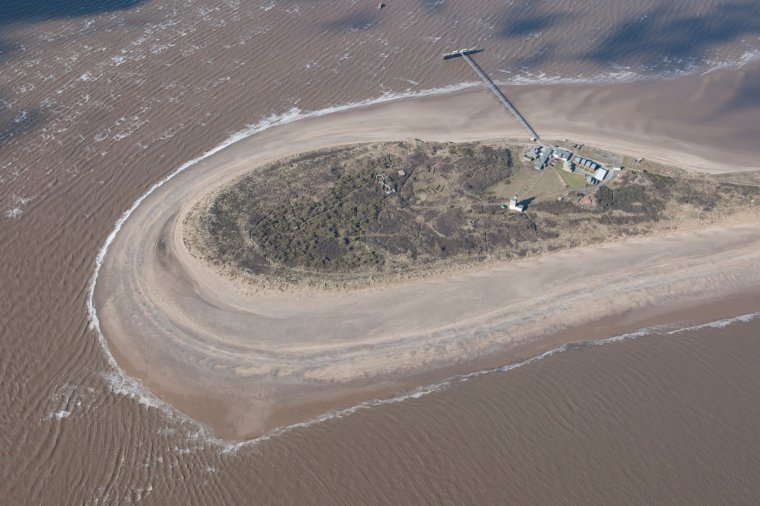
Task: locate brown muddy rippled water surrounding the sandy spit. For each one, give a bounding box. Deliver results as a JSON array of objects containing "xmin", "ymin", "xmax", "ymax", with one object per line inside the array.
[{"xmin": 0, "ymin": 0, "xmax": 760, "ymax": 504}]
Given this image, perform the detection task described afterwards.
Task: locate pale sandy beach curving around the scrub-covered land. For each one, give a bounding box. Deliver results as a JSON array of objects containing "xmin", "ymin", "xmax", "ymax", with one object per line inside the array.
[{"xmin": 93, "ymin": 78, "xmax": 760, "ymax": 439}]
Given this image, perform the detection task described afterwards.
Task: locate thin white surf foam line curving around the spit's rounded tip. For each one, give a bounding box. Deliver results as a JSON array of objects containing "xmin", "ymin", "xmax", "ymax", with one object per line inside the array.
[{"xmin": 87, "ymin": 82, "xmax": 760, "ymax": 453}]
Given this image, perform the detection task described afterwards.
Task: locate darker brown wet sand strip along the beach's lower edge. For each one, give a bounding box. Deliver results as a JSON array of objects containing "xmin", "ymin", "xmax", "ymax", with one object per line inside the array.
[{"xmin": 105, "ymin": 284, "xmax": 760, "ymax": 442}]
